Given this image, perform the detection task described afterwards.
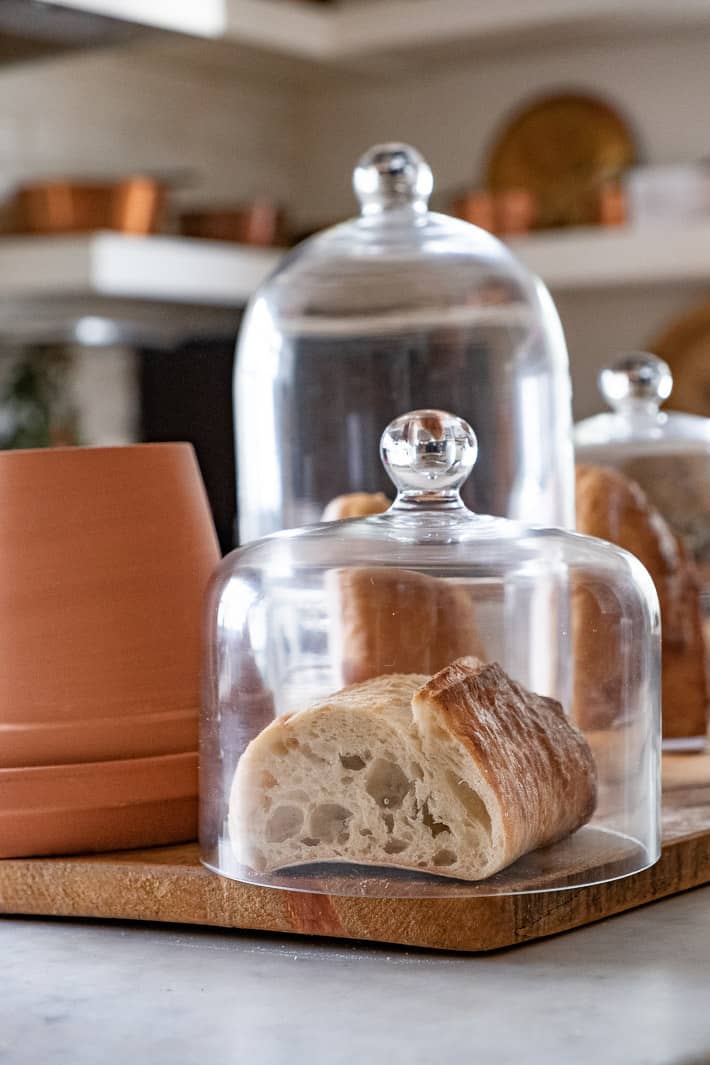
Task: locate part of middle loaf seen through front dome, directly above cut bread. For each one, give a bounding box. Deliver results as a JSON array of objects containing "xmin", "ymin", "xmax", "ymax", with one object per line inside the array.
[{"xmin": 326, "ymin": 566, "xmax": 484, "ymax": 685}]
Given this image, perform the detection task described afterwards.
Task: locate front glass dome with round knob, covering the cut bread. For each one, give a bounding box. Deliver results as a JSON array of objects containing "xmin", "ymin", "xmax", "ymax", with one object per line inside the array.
[{"xmin": 200, "ymin": 410, "xmax": 660, "ymax": 897}]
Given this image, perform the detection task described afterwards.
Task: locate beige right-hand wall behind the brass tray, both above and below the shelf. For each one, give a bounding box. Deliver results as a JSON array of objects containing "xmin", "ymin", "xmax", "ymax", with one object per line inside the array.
[{"xmin": 299, "ymin": 31, "xmax": 710, "ymax": 417}]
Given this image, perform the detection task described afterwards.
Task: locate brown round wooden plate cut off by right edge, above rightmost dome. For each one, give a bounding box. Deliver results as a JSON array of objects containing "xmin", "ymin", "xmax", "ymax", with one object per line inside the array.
[{"xmin": 648, "ymin": 299, "xmax": 710, "ymax": 417}]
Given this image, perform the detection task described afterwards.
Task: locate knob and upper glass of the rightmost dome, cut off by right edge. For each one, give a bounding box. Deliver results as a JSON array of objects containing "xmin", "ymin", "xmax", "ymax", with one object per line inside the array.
[{"xmin": 575, "ymin": 351, "xmax": 710, "ymax": 617}]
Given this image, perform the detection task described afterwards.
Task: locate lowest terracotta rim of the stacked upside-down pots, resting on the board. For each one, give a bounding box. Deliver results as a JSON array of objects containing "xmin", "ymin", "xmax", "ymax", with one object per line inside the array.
[{"xmin": 0, "ymin": 754, "xmax": 197, "ymax": 858}]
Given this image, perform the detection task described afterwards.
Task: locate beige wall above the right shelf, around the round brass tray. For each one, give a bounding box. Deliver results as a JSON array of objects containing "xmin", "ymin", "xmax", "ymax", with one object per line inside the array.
[{"xmin": 299, "ymin": 32, "xmax": 710, "ymax": 224}]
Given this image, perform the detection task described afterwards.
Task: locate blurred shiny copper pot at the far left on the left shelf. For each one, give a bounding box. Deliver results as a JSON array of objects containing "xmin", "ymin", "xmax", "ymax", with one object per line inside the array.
[{"xmin": 15, "ymin": 177, "xmax": 167, "ymax": 234}]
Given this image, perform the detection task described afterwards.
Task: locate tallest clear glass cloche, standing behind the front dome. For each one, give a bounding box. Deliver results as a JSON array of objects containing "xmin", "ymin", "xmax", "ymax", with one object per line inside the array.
[{"xmin": 235, "ymin": 144, "xmax": 574, "ymax": 543}]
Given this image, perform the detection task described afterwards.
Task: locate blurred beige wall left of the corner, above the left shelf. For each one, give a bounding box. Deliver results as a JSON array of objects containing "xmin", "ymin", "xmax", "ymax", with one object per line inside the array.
[{"xmin": 0, "ymin": 42, "xmax": 301, "ymax": 202}]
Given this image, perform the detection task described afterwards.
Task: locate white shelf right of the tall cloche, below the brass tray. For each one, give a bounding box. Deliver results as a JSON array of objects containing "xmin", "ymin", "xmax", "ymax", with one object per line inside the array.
[{"xmin": 509, "ymin": 220, "xmax": 710, "ymax": 291}]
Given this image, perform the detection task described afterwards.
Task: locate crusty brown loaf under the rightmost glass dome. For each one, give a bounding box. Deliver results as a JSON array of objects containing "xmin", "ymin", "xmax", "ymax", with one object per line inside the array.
[{"xmin": 574, "ymin": 465, "xmax": 709, "ymax": 739}]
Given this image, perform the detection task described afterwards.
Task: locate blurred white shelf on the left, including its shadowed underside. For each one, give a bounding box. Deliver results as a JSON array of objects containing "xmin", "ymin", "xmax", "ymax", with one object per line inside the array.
[{"xmin": 0, "ymin": 232, "xmax": 283, "ymax": 351}]
